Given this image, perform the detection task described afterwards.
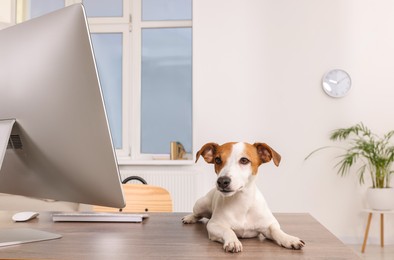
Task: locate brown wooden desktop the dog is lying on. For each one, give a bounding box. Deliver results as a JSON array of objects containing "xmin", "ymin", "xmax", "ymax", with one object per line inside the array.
[{"xmin": 0, "ymin": 212, "xmax": 359, "ymax": 260}]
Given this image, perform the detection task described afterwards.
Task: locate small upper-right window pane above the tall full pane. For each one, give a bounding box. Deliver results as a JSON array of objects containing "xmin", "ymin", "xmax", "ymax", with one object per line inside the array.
[{"xmin": 142, "ymin": 0, "xmax": 192, "ymax": 21}]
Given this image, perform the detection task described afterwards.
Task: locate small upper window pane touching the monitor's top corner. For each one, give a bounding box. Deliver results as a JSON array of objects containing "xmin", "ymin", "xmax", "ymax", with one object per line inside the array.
[{"xmin": 82, "ymin": 0, "xmax": 123, "ymax": 17}]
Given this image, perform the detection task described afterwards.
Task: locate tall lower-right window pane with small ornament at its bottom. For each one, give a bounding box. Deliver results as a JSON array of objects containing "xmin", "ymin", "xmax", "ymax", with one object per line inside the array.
[{"xmin": 141, "ymin": 28, "xmax": 192, "ymax": 154}]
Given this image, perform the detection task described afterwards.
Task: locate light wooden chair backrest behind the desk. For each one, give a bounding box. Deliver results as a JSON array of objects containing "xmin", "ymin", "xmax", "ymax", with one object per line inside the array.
[{"xmin": 93, "ymin": 184, "xmax": 172, "ymax": 212}]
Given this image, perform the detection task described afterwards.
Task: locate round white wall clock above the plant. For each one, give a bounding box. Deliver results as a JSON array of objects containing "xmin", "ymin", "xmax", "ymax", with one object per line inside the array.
[{"xmin": 323, "ymin": 69, "xmax": 352, "ymax": 97}]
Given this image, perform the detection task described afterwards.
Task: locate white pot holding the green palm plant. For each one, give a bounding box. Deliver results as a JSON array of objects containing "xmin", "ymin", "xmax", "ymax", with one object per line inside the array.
[{"xmin": 367, "ymin": 188, "xmax": 394, "ymax": 210}]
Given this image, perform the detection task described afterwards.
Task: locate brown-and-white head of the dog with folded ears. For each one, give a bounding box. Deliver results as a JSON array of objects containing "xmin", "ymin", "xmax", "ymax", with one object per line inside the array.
[{"xmin": 196, "ymin": 143, "xmax": 281, "ymax": 196}]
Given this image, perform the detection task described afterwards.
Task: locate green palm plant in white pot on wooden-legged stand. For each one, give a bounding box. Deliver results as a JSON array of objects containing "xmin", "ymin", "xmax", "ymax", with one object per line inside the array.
[{"xmin": 305, "ymin": 123, "xmax": 394, "ymax": 210}]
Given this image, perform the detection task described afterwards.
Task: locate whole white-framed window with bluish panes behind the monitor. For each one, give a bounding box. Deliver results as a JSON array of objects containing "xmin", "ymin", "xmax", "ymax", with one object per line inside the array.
[{"xmin": 17, "ymin": 0, "xmax": 193, "ymax": 164}]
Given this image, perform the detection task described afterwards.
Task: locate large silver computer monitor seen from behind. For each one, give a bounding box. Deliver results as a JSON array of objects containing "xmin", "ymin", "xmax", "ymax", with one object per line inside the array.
[{"xmin": 0, "ymin": 4, "xmax": 125, "ymax": 208}]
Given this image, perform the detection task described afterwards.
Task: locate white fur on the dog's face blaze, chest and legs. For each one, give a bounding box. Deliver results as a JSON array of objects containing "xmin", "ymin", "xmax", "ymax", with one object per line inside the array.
[{"xmin": 183, "ymin": 143, "xmax": 304, "ymax": 252}]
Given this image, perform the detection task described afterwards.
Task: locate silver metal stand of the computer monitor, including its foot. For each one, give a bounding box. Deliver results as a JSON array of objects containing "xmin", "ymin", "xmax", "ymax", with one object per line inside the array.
[{"xmin": 0, "ymin": 119, "xmax": 62, "ymax": 247}]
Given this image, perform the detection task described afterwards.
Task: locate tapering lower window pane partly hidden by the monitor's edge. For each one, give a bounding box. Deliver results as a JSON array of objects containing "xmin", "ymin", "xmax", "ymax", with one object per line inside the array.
[{"xmin": 91, "ymin": 33, "xmax": 123, "ymax": 149}]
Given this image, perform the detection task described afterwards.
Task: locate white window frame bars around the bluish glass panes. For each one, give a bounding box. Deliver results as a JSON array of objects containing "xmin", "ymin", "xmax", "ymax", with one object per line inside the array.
[{"xmin": 13, "ymin": 0, "xmax": 194, "ymax": 165}]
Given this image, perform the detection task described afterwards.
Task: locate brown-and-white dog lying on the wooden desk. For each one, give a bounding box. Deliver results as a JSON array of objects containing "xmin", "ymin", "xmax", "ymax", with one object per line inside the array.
[{"xmin": 182, "ymin": 142, "xmax": 305, "ymax": 253}]
